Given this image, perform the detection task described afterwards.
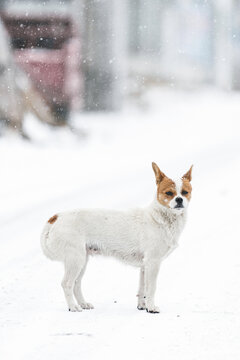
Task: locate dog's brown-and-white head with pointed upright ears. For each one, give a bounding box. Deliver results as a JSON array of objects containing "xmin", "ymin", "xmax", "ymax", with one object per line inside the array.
[{"xmin": 152, "ymin": 163, "xmax": 193, "ymax": 214}]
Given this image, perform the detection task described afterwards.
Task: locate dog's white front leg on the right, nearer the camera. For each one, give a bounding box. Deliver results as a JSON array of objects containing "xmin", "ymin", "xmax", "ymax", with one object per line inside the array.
[{"xmin": 144, "ymin": 261, "xmax": 160, "ymax": 313}]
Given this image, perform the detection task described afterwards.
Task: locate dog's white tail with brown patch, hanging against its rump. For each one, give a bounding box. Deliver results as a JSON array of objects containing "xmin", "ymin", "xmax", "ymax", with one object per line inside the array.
[{"xmin": 41, "ymin": 215, "xmax": 58, "ymax": 260}]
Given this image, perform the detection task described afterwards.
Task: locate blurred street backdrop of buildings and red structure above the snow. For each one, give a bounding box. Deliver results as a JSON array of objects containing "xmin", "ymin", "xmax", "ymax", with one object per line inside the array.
[{"xmin": 0, "ymin": 0, "xmax": 240, "ymax": 135}]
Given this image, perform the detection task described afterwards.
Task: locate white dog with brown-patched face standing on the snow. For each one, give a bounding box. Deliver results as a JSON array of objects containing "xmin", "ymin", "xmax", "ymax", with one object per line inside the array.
[{"xmin": 41, "ymin": 163, "xmax": 192, "ymax": 313}]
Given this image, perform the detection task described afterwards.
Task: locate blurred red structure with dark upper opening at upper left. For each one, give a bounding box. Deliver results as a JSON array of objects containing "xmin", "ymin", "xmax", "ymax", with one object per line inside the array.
[{"xmin": 2, "ymin": 12, "xmax": 81, "ymax": 122}]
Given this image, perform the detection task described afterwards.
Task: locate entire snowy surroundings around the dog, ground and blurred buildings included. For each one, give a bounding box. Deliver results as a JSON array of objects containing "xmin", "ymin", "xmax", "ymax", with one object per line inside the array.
[{"xmin": 0, "ymin": 0, "xmax": 240, "ymax": 360}]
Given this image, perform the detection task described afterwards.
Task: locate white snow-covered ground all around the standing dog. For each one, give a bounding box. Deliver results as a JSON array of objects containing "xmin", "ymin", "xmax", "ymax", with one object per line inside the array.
[{"xmin": 0, "ymin": 89, "xmax": 240, "ymax": 360}]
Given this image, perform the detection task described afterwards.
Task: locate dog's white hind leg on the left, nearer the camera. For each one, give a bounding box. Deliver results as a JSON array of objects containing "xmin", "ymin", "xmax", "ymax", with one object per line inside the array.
[{"xmin": 62, "ymin": 254, "xmax": 85, "ymax": 311}]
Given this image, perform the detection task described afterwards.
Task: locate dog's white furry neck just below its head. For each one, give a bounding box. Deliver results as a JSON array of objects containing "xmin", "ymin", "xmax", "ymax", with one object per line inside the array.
[{"xmin": 149, "ymin": 196, "xmax": 187, "ymax": 226}]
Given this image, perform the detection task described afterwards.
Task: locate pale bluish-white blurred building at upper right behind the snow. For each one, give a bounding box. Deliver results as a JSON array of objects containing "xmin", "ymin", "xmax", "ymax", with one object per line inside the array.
[{"xmin": 129, "ymin": 0, "xmax": 240, "ymax": 90}]
